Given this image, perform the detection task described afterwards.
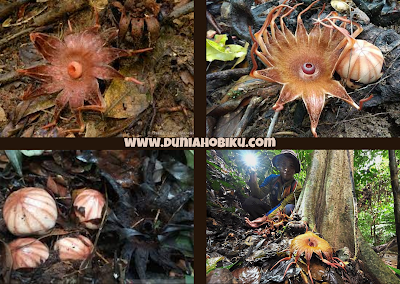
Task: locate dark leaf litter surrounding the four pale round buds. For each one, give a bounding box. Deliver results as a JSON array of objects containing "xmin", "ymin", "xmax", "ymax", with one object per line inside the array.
[{"xmin": 0, "ymin": 151, "xmax": 194, "ymax": 284}]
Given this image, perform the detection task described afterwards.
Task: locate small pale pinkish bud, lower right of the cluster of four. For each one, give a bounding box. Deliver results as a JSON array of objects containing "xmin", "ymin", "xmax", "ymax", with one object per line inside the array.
[{"xmin": 54, "ymin": 235, "xmax": 93, "ymax": 260}]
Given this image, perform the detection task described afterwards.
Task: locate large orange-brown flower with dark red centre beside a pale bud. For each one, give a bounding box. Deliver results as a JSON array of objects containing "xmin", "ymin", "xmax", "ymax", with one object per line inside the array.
[{"xmin": 250, "ymin": 1, "xmax": 362, "ymax": 137}]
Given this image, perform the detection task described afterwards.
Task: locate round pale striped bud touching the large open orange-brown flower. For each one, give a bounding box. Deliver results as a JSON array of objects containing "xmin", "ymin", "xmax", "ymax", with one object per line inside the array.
[{"xmin": 336, "ymin": 39, "xmax": 384, "ymax": 89}]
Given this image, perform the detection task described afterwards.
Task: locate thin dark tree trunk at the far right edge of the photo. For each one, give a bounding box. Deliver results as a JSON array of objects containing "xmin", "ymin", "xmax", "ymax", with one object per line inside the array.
[{"xmin": 389, "ymin": 150, "xmax": 400, "ymax": 269}]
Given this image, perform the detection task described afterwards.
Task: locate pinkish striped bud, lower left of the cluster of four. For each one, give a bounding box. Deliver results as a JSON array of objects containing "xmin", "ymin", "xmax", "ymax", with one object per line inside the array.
[{"xmin": 8, "ymin": 238, "xmax": 49, "ymax": 270}]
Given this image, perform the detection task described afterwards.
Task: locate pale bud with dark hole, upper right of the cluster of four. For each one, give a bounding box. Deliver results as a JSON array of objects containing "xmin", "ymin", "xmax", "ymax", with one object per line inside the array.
[{"xmin": 74, "ymin": 189, "xmax": 106, "ymax": 229}]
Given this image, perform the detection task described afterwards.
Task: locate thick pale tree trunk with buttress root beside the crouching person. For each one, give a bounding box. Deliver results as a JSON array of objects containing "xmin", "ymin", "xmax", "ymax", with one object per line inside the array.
[{"xmin": 296, "ymin": 150, "xmax": 400, "ymax": 284}]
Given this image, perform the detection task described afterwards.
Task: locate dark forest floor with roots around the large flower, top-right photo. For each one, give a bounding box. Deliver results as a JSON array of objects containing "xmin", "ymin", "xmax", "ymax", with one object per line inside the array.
[{"xmin": 207, "ymin": 0, "xmax": 400, "ymax": 137}]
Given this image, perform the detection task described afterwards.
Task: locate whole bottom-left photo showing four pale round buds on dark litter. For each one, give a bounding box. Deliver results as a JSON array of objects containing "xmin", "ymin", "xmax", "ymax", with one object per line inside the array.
[{"xmin": 0, "ymin": 150, "xmax": 194, "ymax": 284}]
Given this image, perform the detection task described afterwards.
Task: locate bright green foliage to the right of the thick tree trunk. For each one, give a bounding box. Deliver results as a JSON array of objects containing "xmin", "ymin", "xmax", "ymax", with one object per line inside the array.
[{"xmin": 354, "ymin": 150, "xmax": 400, "ymax": 245}]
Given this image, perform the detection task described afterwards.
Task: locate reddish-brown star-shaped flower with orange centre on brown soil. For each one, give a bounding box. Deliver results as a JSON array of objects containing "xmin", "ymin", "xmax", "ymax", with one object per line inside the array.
[{"xmin": 17, "ymin": 25, "xmax": 151, "ymax": 132}]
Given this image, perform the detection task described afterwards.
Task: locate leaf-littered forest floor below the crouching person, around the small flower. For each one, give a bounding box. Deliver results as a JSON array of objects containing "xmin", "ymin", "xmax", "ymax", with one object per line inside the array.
[{"xmin": 206, "ymin": 151, "xmax": 397, "ymax": 284}]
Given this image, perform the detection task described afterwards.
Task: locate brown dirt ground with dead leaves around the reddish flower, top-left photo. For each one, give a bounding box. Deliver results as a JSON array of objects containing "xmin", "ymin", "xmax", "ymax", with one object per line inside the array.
[{"xmin": 0, "ymin": 0, "xmax": 194, "ymax": 137}]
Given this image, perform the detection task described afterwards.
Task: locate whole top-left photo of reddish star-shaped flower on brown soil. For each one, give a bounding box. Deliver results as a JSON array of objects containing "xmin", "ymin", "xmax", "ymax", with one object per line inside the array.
[{"xmin": 0, "ymin": 0, "xmax": 194, "ymax": 137}]
